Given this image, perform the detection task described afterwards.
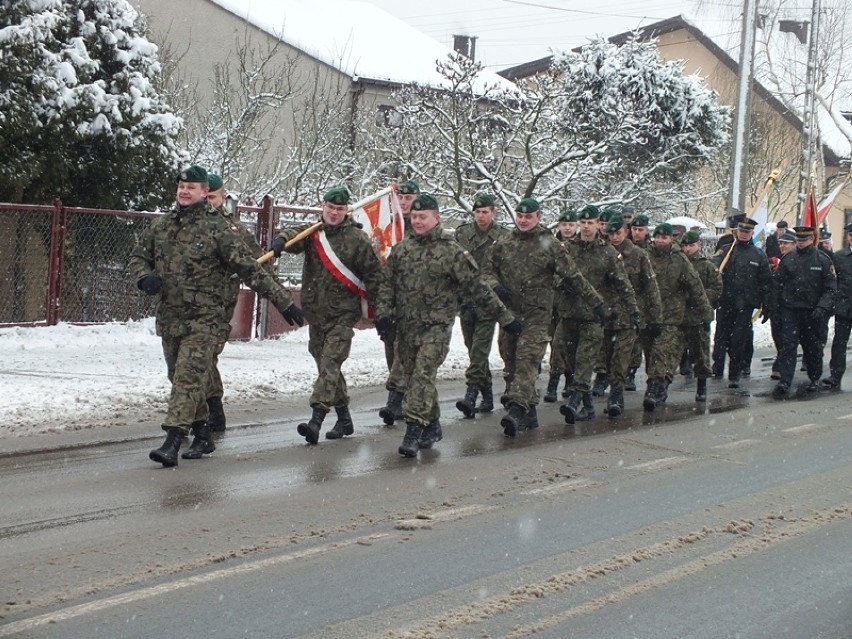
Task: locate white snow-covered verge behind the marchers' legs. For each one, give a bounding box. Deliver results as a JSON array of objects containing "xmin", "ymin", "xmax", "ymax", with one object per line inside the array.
[{"xmin": 0, "ymin": 319, "xmax": 771, "ymax": 437}]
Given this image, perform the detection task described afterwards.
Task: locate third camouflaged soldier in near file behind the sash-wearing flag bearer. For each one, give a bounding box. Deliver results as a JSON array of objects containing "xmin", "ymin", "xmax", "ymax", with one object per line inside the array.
[{"xmin": 558, "ymin": 204, "xmax": 639, "ymax": 424}]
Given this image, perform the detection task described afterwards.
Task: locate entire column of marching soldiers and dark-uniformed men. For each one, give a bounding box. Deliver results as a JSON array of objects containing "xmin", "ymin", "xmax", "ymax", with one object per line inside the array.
[{"xmin": 130, "ymin": 166, "xmax": 852, "ymax": 467}]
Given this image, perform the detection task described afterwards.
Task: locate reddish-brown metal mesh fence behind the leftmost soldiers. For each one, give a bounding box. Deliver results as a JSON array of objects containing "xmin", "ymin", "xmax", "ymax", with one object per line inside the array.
[{"xmin": 0, "ymin": 198, "xmax": 320, "ymax": 332}]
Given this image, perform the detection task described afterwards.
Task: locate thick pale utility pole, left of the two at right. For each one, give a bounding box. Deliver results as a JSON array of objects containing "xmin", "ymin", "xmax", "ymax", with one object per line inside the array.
[{"xmin": 728, "ymin": 0, "xmax": 757, "ymax": 212}]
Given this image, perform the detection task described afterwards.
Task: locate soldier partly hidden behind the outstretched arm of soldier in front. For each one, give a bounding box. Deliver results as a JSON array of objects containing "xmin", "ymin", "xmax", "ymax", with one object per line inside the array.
[{"xmin": 456, "ymin": 193, "xmax": 509, "ymax": 417}]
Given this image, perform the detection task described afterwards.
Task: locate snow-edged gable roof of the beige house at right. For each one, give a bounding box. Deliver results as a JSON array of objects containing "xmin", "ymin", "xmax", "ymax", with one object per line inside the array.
[{"xmin": 500, "ymin": 15, "xmax": 852, "ymax": 165}]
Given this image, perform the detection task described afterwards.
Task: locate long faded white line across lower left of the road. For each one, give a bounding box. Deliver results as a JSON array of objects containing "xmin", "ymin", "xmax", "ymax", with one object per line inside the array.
[{"xmin": 0, "ymin": 533, "xmax": 390, "ymax": 637}]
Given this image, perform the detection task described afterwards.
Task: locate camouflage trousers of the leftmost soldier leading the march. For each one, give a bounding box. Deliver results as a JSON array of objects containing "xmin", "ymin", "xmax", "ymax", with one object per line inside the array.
[{"xmin": 161, "ymin": 331, "xmax": 222, "ymax": 434}]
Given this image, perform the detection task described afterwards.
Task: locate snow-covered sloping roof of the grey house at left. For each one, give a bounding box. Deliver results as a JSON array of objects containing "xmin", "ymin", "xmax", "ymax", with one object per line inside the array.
[{"xmin": 212, "ymin": 0, "xmax": 516, "ymax": 90}]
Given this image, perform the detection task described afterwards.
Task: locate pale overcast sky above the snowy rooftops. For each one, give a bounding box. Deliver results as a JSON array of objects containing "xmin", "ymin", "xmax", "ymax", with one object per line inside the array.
[{"xmin": 369, "ymin": 0, "xmax": 742, "ymax": 70}]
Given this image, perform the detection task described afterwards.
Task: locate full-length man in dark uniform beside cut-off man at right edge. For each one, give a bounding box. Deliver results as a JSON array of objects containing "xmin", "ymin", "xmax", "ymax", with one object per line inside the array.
[{"xmin": 772, "ymin": 226, "xmax": 837, "ymax": 399}]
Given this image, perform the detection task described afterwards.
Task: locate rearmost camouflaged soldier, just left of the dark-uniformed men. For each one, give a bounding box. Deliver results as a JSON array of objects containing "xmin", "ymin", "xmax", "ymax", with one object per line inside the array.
[{"xmin": 681, "ymin": 231, "xmax": 722, "ymax": 402}]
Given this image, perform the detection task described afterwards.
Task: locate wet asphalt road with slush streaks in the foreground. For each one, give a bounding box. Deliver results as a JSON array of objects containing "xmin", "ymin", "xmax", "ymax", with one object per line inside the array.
[{"xmin": 0, "ymin": 374, "xmax": 852, "ymax": 639}]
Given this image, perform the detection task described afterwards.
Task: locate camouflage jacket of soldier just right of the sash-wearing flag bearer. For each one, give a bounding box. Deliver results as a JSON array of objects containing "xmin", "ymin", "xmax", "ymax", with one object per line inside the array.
[{"xmin": 376, "ymin": 224, "xmax": 514, "ymax": 330}]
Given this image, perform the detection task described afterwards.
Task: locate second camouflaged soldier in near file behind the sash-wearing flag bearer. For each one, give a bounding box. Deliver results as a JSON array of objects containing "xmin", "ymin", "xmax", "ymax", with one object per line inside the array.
[{"xmin": 488, "ymin": 198, "xmax": 606, "ymax": 437}]
